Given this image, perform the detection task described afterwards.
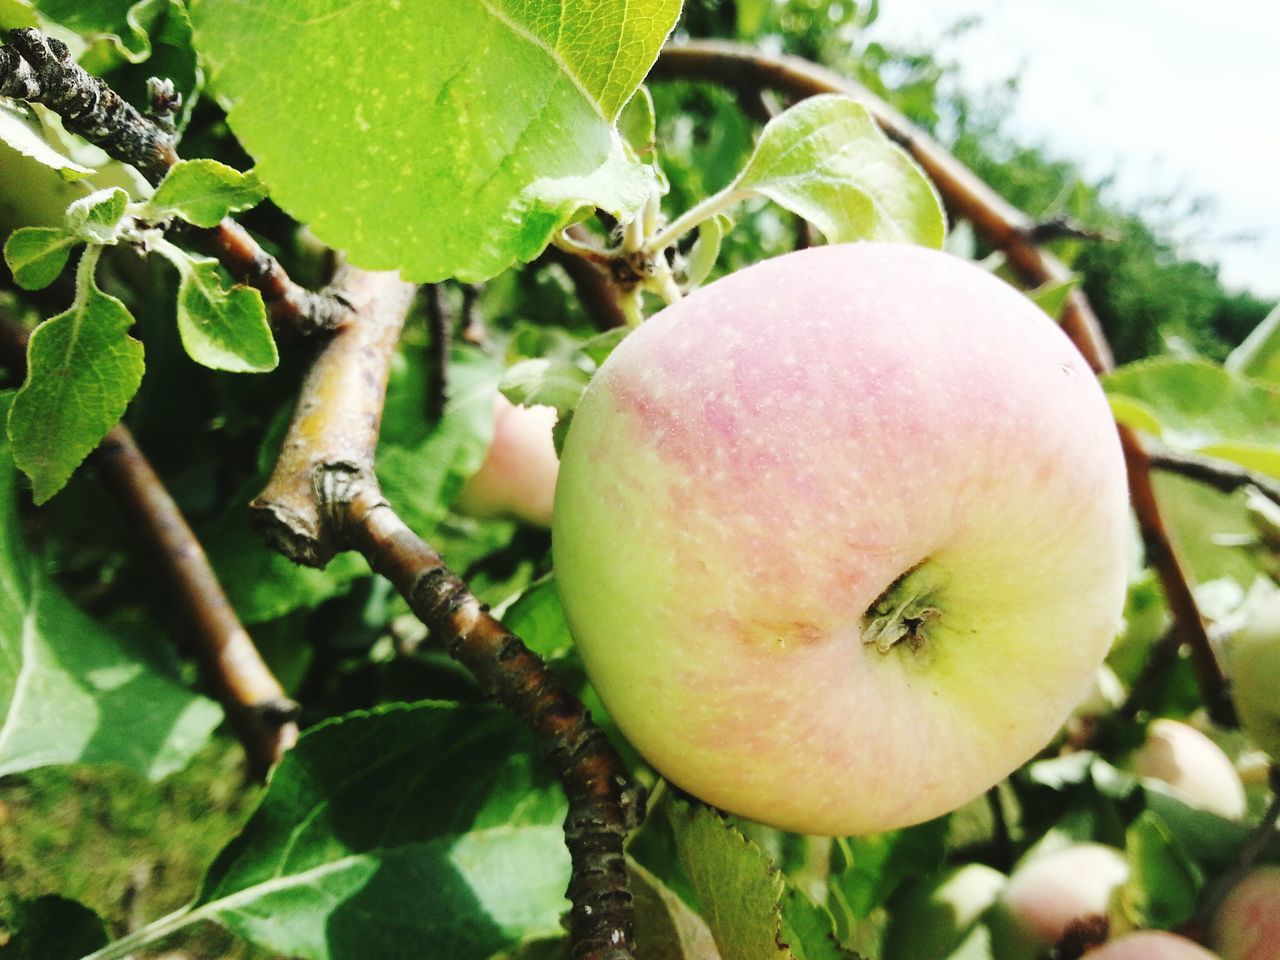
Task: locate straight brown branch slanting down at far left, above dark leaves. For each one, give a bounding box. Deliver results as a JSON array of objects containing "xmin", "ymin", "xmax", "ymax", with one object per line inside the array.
[{"xmin": 0, "ymin": 320, "xmax": 298, "ymax": 780}]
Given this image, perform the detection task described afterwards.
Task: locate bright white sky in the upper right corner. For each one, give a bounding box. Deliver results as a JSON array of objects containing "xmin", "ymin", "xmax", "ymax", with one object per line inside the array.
[{"xmin": 868, "ymin": 0, "xmax": 1280, "ymax": 297}]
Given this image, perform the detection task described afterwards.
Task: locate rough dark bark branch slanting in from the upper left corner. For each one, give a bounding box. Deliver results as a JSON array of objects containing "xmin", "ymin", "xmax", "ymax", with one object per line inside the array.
[{"xmin": 0, "ymin": 29, "xmax": 348, "ymax": 334}]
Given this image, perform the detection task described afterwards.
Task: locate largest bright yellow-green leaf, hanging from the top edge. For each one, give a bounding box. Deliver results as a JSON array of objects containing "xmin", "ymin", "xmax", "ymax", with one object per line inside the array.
[{"xmin": 192, "ymin": 0, "xmax": 680, "ymax": 282}]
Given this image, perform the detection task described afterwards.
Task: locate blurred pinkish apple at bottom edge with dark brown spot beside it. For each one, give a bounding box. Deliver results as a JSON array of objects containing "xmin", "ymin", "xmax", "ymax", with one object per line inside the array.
[{"xmin": 988, "ymin": 844, "xmax": 1129, "ymax": 959}]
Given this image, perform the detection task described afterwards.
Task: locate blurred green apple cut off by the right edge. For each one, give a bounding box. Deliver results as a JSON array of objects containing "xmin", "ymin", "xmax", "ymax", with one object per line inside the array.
[{"xmin": 1226, "ymin": 591, "xmax": 1280, "ymax": 762}]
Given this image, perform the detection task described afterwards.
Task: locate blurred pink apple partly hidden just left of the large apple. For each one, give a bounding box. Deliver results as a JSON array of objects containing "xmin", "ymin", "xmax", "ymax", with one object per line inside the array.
[{"xmin": 453, "ymin": 393, "xmax": 559, "ymax": 526}]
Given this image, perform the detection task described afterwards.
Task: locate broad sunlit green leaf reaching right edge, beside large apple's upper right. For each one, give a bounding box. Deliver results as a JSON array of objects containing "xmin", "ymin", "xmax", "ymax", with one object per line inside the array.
[{"xmin": 1103, "ymin": 357, "xmax": 1280, "ymax": 476}]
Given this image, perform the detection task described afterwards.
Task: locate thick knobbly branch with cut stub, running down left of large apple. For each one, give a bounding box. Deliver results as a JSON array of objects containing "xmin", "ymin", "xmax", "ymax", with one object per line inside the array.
[{"xmin": 252, "ymin": 268, "xmax": 643, "ymax": 960}]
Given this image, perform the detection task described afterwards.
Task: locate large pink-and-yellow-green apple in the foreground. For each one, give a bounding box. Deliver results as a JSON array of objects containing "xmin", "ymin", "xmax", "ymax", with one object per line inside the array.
[{"xmin": 552, "ymin": 243, "xmax": 1129, "ymax": 835}]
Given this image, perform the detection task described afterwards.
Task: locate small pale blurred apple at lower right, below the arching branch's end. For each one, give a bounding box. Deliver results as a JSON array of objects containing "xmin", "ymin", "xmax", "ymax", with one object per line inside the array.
[{"xmin": 1134, "ymin": 719, "xmax": 1245, "ymax": 820}]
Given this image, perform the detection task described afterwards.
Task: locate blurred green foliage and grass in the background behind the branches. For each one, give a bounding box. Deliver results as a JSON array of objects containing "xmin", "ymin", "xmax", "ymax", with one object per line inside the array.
[{"xmin": 0, "ymin": 0, "xmax": 1271, "ymax": 957}]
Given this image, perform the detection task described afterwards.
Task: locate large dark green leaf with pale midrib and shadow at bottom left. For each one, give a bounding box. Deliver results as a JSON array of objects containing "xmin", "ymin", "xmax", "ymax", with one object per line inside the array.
[{"xmin": 176, "ymin": 703, "xmax": 570, "ymax": 960}]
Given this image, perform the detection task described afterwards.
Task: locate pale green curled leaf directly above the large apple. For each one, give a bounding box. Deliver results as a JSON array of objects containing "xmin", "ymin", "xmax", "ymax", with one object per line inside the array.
[{"xmin": 731, "ymin": 93, "xmax": 946, "ymax": 247}]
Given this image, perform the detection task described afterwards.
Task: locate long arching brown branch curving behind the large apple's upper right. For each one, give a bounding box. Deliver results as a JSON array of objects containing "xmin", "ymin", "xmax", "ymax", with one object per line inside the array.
[{"xmin": 649, "ymin": 41, "xmax": 1235, "ymax": 726}]
